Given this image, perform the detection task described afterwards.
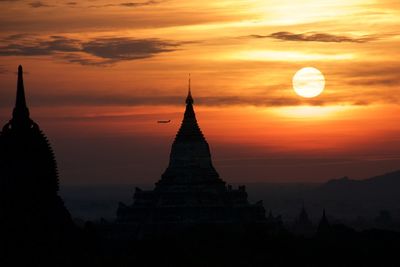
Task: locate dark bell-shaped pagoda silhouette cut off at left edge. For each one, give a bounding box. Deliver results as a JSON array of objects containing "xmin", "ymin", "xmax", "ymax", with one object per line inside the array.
[{"xmin": 0, "ymin": 66, "xmax": 73, "ymax": 240}]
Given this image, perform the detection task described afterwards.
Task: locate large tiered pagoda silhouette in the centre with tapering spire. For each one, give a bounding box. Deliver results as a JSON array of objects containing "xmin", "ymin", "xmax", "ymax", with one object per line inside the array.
[{"xmin": 117, "ymin": 77, "xmax": 266, "ymax": 232}]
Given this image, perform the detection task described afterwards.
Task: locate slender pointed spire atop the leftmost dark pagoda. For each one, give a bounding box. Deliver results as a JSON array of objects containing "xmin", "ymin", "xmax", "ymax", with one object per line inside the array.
[{"xmin": 13, "ymin": 65, "xmax": 30, "ymax": 122}]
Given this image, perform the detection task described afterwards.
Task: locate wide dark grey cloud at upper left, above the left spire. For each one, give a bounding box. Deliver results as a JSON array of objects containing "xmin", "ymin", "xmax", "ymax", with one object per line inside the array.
[{"xmin": 0, "ymin": 34, "xmax": 182, "ymax": 65}]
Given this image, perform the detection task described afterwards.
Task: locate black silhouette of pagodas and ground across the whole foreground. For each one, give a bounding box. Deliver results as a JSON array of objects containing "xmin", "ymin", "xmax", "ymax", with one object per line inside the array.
[{"xmin": 0, "ymin": 67, "xmax": 400, "ymax": 267}]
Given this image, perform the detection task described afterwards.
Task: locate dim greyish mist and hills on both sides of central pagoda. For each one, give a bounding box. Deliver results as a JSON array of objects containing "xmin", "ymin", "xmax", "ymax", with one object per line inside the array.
[{"xmin": 61, "ymin": 172, "xmax": 400, "ymax": 229}]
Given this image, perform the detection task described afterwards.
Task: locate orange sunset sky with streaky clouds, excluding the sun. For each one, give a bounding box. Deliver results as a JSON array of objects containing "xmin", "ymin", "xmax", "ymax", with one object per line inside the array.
[{"xmin": 0, "ymin": 0, "xmax": 400, "ymax": 184}]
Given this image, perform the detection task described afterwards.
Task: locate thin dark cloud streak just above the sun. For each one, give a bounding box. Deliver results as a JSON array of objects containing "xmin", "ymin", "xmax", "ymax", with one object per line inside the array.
[{"xmin": 249, "ymin": 32, "xmax": 376, "ymax": 43}]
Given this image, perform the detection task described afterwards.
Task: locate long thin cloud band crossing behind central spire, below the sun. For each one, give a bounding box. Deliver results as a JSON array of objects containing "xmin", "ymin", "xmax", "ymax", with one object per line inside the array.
[{"xmin": 0, "ymin": 92, "xmax": 378, "ymax": 107}]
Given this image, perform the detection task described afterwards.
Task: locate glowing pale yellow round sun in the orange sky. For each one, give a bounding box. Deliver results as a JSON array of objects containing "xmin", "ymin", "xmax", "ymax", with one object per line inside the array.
[{"xmin": 293, "ymin": 67, "xmax": 325, "ymax": 98}]
